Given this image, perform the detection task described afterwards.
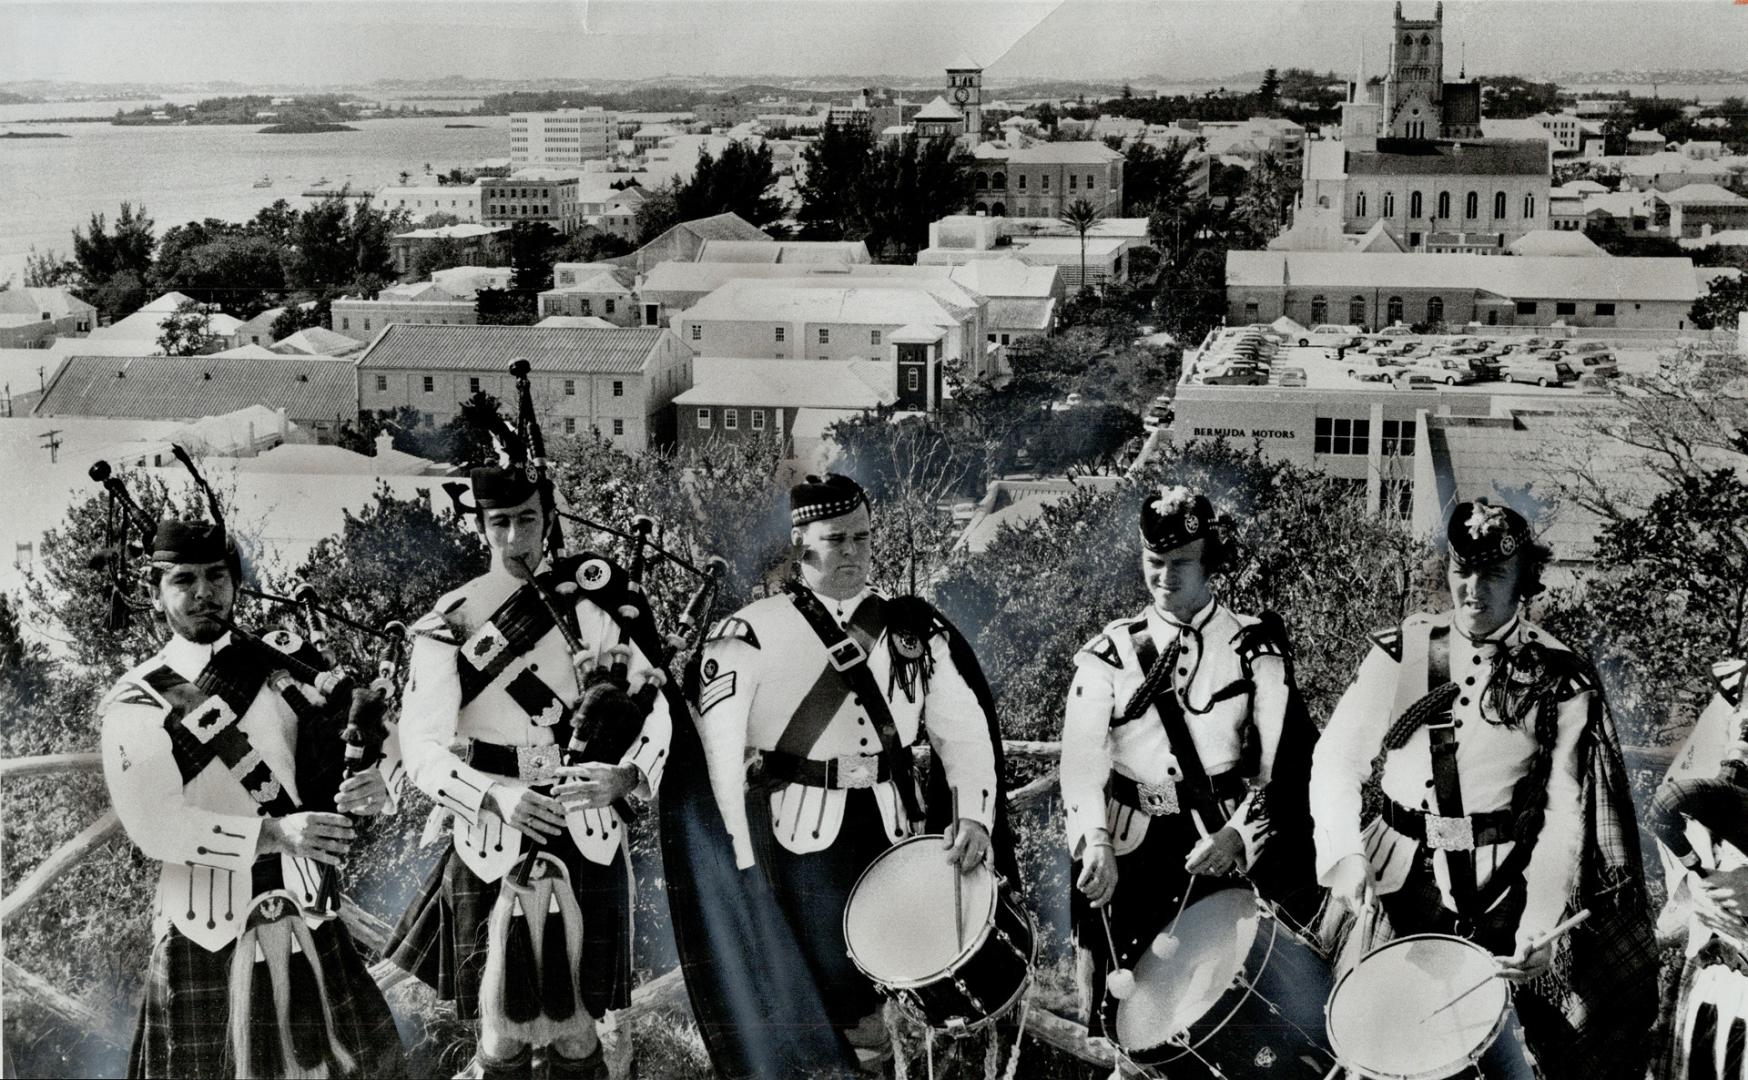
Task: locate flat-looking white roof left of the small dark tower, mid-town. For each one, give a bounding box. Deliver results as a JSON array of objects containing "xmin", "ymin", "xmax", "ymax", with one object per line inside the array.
[{"xmin": 673, "ymin": 357, "xmax": 897, "ymax": 409}]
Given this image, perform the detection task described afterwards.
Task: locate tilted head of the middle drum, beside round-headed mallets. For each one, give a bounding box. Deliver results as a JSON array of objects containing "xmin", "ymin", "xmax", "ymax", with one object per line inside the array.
[{"xmin": 1117, "ymin": 890, "xmax": 1262, "ymax": 1050}]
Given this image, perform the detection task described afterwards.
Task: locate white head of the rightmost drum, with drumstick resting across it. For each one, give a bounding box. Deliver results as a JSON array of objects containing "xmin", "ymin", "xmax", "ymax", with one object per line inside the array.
[{"xmin": 1328, "ymin": 933, "xmax": 1510, "ymax": 1080}]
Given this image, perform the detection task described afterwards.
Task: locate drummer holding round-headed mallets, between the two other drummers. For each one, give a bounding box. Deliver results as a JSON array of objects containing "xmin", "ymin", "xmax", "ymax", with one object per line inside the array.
[{"xmin": 1061, "ymin": 488, "xmax": 1316, "ymax": 1038}]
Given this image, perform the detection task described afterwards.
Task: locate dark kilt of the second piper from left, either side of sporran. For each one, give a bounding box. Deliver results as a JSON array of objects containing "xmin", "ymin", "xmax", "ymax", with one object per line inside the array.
[{"xmin": 386, "ymin": 832, "xmax": 631, "ymax": 1021}]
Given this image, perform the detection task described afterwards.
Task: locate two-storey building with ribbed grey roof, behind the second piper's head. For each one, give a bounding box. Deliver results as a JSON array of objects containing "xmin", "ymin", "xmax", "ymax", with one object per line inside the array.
[{"xmin": 357, "ymin": 325, "xmax": 692, "ymax": 451}]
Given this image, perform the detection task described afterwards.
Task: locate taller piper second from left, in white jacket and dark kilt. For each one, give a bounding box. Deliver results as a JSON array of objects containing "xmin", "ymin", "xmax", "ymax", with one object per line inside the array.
[{"xmin": 388, "ymin": 463, "xmax": 671, "ymax": 1078}]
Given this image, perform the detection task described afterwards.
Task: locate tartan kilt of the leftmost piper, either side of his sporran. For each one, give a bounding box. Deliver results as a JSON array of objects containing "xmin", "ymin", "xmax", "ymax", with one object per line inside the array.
[{"xmin": 128, "ymin": 919, "xmax": 407, "ymax": 1080}]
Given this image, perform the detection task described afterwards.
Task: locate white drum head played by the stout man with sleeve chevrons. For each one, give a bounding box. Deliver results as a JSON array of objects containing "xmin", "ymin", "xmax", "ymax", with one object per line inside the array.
[{"xmin": 844, "ymin": 834, "xmax": 995, "ymax": 987}]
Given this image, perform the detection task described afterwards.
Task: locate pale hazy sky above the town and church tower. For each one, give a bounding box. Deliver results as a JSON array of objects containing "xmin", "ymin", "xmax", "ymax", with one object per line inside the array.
[{"xmin": 0, "ymin": 0, "xmax": 1748, "ymax": 84}]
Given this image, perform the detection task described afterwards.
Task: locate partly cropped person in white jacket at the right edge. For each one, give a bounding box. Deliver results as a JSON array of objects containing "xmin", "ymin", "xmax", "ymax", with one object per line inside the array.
[{"xmin": 1647, "ymin": 659, "xmax": 1748, "ymax": 1077}]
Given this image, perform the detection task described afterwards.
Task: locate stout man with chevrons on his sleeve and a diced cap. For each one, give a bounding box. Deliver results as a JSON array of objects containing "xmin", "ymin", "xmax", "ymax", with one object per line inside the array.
[{"xmin": 662, "ymin": 474, "xmax": 1014, "ymax": 1077}]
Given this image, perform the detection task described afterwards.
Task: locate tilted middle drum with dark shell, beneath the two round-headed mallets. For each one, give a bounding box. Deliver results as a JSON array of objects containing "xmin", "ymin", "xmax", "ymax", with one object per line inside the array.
[{"xmin": 1115, "ymin": 888, "xmax": 1334, "ymax": 1078}]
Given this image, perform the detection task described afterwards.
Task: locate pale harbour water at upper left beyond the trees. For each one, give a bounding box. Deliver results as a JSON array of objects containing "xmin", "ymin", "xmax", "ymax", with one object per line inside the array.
[{"xmin": 0, "ymin": 113, "xmax": 510, "ymax": 281}]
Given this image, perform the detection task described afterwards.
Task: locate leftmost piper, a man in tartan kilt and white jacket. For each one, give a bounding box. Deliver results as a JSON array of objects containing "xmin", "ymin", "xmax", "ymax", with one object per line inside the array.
[{"xmin": 100, "ymin": 521, "xmax": 406, "ymax": 1078}]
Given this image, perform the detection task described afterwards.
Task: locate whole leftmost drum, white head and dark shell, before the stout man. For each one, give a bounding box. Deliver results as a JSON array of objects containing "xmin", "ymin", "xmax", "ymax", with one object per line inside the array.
[{"xmin": 844, "ymin": 834, "xmax": 1037, "ymax": 1031}]
